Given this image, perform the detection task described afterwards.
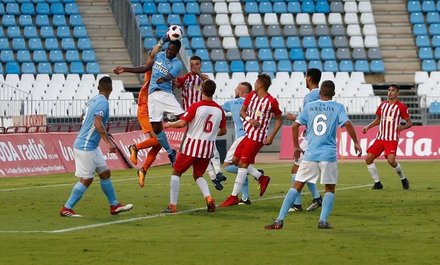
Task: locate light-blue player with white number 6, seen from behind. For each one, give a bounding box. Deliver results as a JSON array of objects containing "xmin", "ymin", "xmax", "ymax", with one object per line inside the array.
[{"xmin": 265, "ymin": 80, "xmax": 362, "ymax": 229}]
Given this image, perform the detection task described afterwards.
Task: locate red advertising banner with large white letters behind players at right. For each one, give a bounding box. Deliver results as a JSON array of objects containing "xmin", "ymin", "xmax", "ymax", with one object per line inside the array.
[{"xmin": 279, "ymin": 126, "xmax": 440, "ymax": 159}]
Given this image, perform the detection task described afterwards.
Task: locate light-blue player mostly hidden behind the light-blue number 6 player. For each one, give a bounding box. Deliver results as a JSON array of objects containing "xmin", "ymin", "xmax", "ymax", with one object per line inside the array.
[{"xmin": 287, "ymin": 68, "xmax": 322, "ymax": 212}]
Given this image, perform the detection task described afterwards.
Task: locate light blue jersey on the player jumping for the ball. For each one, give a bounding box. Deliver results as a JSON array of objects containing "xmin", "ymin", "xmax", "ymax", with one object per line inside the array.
[{"xmin": 148, "ymin": 52, "xmax": 183, "ymax": 94}]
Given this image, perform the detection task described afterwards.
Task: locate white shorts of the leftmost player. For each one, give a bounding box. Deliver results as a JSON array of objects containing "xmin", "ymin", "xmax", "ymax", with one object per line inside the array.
[{"xmin": 73, "ymin": 147, "xmax": 108, "ymax": 179}]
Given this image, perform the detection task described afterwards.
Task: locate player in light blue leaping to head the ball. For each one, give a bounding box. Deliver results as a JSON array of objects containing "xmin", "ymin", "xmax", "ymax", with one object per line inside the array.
[{"xmin": 113, "ymin": 34, "xmax": 184, "ymax": 164}]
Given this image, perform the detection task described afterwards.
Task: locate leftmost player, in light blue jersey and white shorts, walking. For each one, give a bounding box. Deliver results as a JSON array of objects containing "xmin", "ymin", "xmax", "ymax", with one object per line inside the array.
[{"xmin": 59, "ymin": 76, "xmax": 133, "ymax": 217}]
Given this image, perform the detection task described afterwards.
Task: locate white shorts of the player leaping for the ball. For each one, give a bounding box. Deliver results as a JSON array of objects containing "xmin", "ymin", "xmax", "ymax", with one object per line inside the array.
[{"xmin": 148, "ymin": 90, "xmax": 185, "ymax": 122}]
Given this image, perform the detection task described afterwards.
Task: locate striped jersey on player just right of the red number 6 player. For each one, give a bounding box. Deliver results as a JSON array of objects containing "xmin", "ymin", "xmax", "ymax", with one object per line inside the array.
[{"xmin": 243, "ymin": 91, "xmax": 281, "ymax": 142}]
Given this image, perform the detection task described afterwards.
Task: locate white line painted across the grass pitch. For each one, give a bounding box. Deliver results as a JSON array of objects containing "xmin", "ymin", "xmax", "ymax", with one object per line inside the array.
[{"xmin": 0, "ymin": 184, "xmax": 371, "ymax": 234}]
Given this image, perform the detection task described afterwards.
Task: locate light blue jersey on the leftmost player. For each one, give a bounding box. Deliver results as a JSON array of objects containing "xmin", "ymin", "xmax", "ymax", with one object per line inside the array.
[{"xmin": 73, "ymin": 94, "xmax": 109, "ymax": 151}]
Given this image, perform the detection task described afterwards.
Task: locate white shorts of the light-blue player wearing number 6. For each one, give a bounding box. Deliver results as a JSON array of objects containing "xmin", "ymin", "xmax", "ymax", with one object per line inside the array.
[{"xmin": 295, "ymin": 160, "xmax": 338, "ymax": 184}]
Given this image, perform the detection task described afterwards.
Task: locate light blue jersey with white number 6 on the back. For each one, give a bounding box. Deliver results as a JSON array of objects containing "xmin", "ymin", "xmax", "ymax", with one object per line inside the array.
[{"xmin": 296, "ymin": 100, "xmax": 349, "ymax": 162}]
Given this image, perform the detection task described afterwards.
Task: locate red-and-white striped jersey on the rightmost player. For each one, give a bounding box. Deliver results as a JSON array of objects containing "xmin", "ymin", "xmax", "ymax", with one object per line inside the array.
[{"xmin": 376, "ymin": 101, "xmax": 409, "ymax": 141}]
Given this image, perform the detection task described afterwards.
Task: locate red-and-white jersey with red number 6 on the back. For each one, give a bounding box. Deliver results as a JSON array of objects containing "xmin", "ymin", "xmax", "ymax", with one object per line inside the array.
[{"xmin": 180, "ymin": 100, "xmax": 226, "ymax": 158}]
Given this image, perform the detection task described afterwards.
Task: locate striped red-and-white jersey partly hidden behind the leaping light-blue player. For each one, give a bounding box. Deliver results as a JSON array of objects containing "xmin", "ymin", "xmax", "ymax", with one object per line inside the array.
[{"xmin": 176, "ymin": 72, "xmax": 203, "ymax": 110}]
